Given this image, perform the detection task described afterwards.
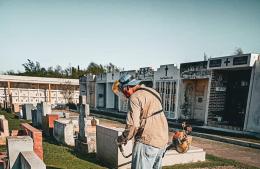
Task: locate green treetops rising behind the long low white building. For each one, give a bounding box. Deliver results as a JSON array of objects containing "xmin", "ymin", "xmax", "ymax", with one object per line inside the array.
[{"xmin": 4, "ymin": 59, "xmax": 120, "ymax": 79}]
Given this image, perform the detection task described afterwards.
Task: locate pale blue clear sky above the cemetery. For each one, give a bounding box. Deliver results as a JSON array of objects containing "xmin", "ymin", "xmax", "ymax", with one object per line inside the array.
[{"xmin": 0, "ymin": 0, "xmax": 260, "ymax": 72}]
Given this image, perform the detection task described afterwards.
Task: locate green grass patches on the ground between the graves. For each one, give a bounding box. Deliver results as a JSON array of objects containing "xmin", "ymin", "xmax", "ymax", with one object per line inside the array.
[{"xmin": 0, "ymin": 110, "xmax": 257, "ymax": 169}]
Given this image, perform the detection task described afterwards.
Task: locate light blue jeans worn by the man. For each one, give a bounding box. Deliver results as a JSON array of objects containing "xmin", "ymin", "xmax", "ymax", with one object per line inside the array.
[{"xmin": 131, "ymin": 142, "xmax": 165, "ymax": 169}]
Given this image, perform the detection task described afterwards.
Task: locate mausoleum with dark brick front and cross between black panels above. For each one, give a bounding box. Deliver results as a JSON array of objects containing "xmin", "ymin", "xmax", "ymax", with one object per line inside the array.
[{"xmin": 207, "ymin": 54, "xmax": 259, "ymax": 130}]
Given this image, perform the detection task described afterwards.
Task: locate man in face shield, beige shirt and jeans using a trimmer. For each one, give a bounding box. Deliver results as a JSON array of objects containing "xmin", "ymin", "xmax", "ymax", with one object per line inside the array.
[{"xmin": 112, "ymin": 74, "xmax": 168, "ymax": 169}]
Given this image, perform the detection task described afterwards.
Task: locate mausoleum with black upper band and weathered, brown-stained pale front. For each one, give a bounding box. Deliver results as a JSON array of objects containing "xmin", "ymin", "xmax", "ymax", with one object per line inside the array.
[{"xmin": 178, "ymin": 61, "xmax": 211, "ymax": 124}]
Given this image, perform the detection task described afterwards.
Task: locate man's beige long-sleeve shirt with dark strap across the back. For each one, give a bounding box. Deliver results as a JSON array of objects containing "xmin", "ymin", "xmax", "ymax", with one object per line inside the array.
[{"xmin": 123, "ymin": 85, "xmax": 168, "ymax": 148}]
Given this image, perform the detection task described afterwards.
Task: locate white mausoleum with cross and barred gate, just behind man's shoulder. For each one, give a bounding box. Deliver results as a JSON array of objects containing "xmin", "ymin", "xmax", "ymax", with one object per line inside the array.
[{"xmin": 153, "ymin": 64, "xmax": 179, "ymax": 119}]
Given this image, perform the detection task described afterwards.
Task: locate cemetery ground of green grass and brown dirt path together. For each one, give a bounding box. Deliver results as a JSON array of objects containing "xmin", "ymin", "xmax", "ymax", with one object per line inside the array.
[{"xmin": 0, "ymin": 110, "xmax": 260, "ymax": 169}]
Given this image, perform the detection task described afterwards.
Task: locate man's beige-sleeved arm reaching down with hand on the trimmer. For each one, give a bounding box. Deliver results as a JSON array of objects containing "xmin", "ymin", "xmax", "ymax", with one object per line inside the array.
[{"xmin": 117, "ymin": 97, "xmax": 142, "ymax": 144}]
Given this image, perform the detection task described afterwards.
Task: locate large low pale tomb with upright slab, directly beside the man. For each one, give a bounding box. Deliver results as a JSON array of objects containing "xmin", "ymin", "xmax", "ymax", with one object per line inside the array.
[{"xmin": 96, "ymin": 125, "xmax": 206, "ymax": 168}]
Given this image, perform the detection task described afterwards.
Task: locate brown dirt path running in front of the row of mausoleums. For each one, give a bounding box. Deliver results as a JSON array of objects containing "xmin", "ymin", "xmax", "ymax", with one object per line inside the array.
[{"xmin": 100, "ymin": 119, "xmax": 260, "ymax": 167}]
